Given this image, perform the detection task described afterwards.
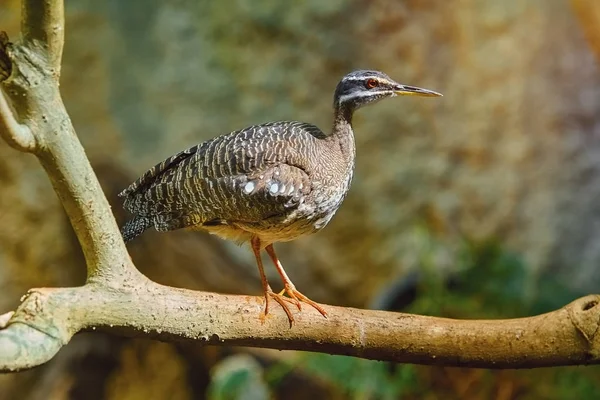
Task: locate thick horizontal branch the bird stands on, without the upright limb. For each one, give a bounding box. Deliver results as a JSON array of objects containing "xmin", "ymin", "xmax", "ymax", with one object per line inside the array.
[{"xmin": 0, "ymin": 280, "xmax": 600, "ymax": 371}]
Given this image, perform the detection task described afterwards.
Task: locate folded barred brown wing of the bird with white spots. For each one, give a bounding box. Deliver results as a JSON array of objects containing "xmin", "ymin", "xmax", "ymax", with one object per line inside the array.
[{"xmin": 122, "ymin": 122, "xmax": 322, "ymax": 230}]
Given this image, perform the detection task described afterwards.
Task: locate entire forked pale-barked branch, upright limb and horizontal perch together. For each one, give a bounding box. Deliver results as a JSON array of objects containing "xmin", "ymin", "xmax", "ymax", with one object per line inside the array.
[{"xmin": 0, "ymin": 0, "xmax": 600, "ymax": 372}]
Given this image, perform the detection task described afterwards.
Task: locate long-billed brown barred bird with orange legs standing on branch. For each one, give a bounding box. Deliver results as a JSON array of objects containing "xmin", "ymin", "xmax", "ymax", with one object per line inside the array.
[{"xmin": 119, "ymin": 70, "xmax": 441, "ymax": 328}]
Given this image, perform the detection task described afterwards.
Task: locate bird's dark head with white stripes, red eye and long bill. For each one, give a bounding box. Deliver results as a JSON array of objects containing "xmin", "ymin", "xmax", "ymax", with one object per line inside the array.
[{"xmin": 333, "ymin": 71, "xmax": 441, "ymax": 111}]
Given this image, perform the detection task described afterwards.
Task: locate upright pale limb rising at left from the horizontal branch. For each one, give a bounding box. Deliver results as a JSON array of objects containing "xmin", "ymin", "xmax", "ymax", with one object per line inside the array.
[{"xmin": 0, "ymin": 0, "xmax": 139, "ymax": 285}]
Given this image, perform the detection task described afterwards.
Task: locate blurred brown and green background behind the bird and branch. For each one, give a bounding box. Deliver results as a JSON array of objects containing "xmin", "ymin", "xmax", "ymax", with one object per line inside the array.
[{"xmin": 0, "ymin": 0, "xmax": 600, "ymax": 400}]
